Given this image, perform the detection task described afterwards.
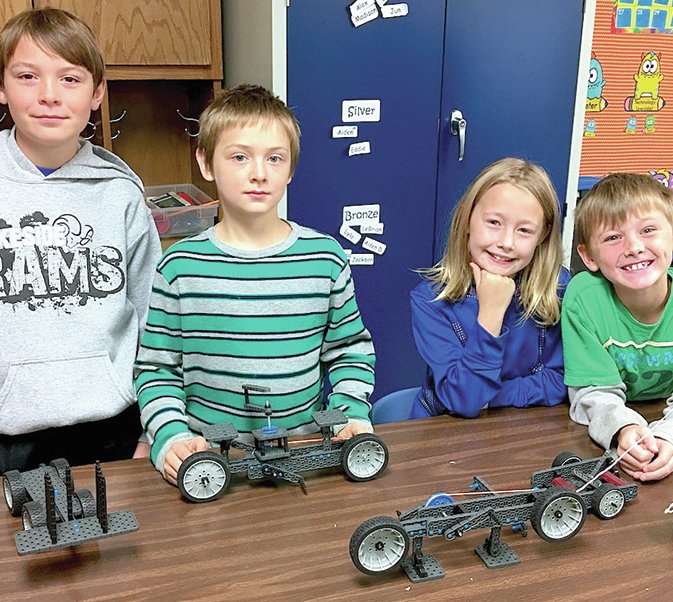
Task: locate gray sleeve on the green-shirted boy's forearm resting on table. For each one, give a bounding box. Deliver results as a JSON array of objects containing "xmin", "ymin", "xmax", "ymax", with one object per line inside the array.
[{"xmin": 568, "ymin": 383, "xmax": 644, "ymax": 449}]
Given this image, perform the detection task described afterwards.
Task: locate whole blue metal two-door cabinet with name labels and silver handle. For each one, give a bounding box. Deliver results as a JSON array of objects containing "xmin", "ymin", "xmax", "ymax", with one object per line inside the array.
[{"xmin": 287, "ymin": 0, "xmax": 583, "ymax": 399}]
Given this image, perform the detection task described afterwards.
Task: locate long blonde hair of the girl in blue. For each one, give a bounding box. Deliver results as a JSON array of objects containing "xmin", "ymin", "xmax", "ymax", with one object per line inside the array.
[{"xmin": 422, "ymin": 157, "xmax": 563, "ymax": 326}]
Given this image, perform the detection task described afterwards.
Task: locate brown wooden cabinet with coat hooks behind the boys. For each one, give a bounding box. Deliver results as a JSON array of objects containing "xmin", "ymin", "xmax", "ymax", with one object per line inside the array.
[{"xmin": 0, "ymin": 0, "xmax": 223, "ymax": 196}]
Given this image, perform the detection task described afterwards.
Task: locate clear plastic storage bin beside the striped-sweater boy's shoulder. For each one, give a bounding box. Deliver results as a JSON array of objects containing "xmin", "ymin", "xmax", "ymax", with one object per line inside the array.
[{"xmin": 145, "ymin": 184, "xmax": 218, "ymax": 238}]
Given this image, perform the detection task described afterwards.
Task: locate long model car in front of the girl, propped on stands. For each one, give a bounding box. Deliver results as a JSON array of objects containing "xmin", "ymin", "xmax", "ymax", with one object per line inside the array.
[{"xmin": 349, "ymin": 452, "xmax": 638, "ymax": 583}]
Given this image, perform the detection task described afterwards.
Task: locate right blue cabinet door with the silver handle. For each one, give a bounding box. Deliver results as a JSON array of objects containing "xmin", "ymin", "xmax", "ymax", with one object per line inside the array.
[{"xmin": 435, "ymin": 0, "xmax": 584, "ymax": 252}]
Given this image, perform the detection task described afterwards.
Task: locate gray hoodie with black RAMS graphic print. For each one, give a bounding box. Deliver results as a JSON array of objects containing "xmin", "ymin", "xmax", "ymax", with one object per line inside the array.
[{"xmin": 0, "ymin": 130, "xmax": 161, "ymax": 435}]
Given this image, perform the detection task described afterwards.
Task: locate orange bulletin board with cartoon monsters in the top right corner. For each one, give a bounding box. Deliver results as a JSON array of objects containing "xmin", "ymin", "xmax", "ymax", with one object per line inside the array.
[{"xmin": 580, "ymin": 0, "xmax": 673, "ymax": 188}]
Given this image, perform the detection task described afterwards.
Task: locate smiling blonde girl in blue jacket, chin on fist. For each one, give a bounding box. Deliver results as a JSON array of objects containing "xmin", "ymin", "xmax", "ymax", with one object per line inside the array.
[{"xmin": 411, "ymin": 158, "xmax": 570, "ymax": 418}]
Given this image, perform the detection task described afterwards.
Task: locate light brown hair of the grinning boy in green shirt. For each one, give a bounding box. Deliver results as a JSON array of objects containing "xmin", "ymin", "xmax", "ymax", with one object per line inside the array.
[{"xmin": 575, "ymin": 173, "xmax": 673, "ymax": 248}]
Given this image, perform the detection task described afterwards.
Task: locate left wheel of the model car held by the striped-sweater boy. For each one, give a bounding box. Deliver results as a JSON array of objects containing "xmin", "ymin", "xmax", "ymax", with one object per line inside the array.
[{"xmin": 178, "ymin": 451, "xmax": 231, "ymax": 502}]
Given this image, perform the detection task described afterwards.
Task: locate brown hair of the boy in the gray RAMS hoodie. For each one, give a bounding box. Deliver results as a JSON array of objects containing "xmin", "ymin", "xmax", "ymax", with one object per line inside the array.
[{"xmin": 0, "ymin": 8, "xmax": 105, "ymax": 89}]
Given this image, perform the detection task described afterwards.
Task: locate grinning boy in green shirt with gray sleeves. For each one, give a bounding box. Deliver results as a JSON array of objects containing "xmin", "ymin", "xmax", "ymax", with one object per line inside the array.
[{"xmin": 562, "ymin": 173, "xmax": 673, "ymax": 481}]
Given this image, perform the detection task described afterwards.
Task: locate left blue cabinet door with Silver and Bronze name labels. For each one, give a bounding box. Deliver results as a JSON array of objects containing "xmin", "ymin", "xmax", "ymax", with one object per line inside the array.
[{"xmin": 287, "ymin": 0, "xmax": 445, "ymax": 398}]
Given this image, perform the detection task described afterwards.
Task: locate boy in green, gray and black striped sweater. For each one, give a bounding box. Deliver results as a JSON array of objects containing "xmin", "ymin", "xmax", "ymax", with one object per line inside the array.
[{"xmin": 136, "ymin": 84, "xmax": 375, "ymax": 483}]
